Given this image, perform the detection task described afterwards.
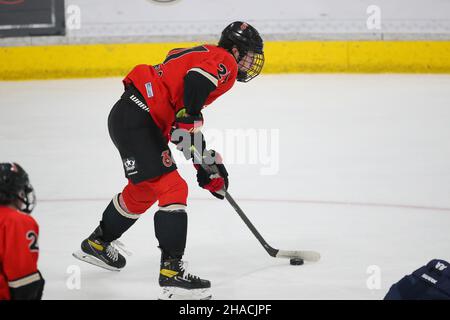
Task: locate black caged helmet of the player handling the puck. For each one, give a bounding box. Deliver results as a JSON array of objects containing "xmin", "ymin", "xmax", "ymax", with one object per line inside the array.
[{"xmin": 219, "ymin": 21, "xmax": 264, "ymax": 82}]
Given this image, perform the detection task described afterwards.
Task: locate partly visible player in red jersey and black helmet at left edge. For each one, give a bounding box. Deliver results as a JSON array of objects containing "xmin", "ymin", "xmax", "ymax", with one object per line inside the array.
[{"xmin": 0, "ymin": 163, "xmax": 45, "ymax": 300}]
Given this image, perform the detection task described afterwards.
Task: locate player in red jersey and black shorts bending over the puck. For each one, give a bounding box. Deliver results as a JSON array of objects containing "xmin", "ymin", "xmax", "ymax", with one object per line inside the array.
[{"xmin": 74, "ymin": 21, "xmax": 264, "ymax": 299}]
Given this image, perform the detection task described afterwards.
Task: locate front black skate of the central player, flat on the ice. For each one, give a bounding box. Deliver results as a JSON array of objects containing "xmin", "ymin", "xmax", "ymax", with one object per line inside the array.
[{"xmin": 159, "ymin": 258, "xmax": 211, "ymax": 300}]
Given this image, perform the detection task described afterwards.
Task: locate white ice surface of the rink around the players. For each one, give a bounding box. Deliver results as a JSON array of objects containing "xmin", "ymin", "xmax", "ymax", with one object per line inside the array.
[{"xmin": 0, "ymin": 74, "xmax": 450, "ymax": 299}]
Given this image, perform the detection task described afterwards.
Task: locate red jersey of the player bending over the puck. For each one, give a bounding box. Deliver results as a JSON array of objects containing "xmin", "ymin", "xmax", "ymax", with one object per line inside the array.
[{"xmin": 123, "ymin": 45, "xmax": 238, "ymax": 136}]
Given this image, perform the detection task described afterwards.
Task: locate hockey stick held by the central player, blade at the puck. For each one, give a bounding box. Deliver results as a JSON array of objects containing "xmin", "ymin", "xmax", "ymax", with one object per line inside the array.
[{"xmin": 193, "ymin": 149, "xmax": 320, "ymax": 262}]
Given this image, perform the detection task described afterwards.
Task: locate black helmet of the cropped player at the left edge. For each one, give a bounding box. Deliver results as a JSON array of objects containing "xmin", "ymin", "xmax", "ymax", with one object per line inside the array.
[{"xmin": 0, "ymin": 163, "xmax": 36, "ymax": 213}]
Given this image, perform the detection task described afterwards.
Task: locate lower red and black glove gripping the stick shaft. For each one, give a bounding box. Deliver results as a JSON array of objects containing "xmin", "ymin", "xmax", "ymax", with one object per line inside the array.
[{"xmin": 194, "ymin": 150, "xmax": 228, "ymax": 199}]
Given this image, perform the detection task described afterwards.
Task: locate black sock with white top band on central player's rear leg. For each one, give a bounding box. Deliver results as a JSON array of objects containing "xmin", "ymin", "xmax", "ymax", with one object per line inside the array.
[{"xmin": 100, "ymin": 195, "xmax": 140, "ymax": 242}]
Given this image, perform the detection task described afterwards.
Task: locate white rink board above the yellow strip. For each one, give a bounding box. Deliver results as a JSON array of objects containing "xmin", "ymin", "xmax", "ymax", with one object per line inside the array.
[{"xmin": 62, "ymin": 0, "xmax": 450, "ymax": 39}]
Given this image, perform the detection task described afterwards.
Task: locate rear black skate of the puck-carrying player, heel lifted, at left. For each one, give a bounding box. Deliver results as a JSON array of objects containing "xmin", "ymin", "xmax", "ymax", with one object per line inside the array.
[{"xmin": 73, "ymin": 226, "xmax": 126, "ymax": 271}]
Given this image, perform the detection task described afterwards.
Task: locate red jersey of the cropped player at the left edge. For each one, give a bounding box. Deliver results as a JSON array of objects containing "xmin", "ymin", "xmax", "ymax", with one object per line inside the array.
[{"xmin": 0, "ymin": 206, "xmax": 40, "ymax": 300}]
